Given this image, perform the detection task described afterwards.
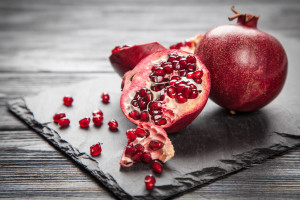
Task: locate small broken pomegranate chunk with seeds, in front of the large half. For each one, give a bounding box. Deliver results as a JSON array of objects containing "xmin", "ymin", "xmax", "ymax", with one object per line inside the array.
[{"xmin": 120, "ymin": 122, "xmax": 175, "ymax": 167}]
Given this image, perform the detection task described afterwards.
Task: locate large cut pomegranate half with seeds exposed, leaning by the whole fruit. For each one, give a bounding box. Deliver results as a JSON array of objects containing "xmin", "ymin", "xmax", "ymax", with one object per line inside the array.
[{"xmin": 121, "ymin": 50, "xmax": 210, "ymax": 133}]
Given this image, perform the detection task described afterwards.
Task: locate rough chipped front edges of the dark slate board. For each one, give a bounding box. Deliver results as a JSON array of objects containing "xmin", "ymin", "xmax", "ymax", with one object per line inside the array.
[{"xmin": 7, "ymin": 98, "xmax": 300, "ymax": 200}]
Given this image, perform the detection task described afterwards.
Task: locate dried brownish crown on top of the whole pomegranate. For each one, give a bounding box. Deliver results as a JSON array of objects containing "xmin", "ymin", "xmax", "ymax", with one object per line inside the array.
[{"xmin": 228, "ymin": 6, "xmax": 259, "ymax": 28}]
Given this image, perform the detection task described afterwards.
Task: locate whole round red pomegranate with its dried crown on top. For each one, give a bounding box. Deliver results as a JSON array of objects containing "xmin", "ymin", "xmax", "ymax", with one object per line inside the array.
[{"xmin": 195, "ymin": 7, "xmax": 288, "ymax": 112}]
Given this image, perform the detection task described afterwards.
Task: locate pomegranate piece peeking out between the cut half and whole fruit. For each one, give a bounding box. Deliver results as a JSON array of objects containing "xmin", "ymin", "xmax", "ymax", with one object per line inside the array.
[{"xmin": 170, "ymin": 34, "xmax": 203, "ymax": 53}]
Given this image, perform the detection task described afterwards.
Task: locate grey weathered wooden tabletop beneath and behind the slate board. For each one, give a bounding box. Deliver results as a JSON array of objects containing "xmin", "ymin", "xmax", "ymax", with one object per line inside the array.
[{"xmin": 0, "ymin": 0, "xmax": 300, "ymax": 199}]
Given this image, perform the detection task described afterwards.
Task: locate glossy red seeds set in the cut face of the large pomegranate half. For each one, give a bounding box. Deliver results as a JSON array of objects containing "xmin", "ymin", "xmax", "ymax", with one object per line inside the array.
[{"xmin": 129, "ymin": 53, "xmax": 203, "ymax": 126}]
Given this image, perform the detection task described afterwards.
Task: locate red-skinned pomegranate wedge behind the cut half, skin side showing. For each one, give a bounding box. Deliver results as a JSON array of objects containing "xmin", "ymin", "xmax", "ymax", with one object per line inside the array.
[{"xmin": 109, "ymin": 42, "xmax": 166, "ymax": 77}]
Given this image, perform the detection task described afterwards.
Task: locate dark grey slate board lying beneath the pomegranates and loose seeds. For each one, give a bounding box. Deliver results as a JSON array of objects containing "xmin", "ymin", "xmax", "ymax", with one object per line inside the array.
[{"xmin": 8, "ymin": 77, "xmax": 300, "ymax": 199}]
